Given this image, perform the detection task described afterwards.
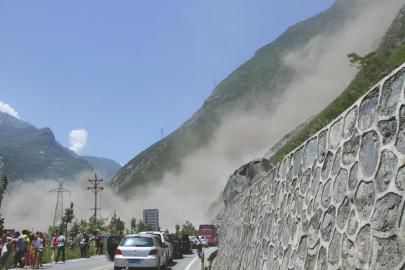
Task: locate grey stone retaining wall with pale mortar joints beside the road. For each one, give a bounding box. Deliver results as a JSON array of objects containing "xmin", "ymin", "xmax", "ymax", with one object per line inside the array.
[{"xmin": 215, "ymin": 64, "xmax": 405, "ymax": 270}]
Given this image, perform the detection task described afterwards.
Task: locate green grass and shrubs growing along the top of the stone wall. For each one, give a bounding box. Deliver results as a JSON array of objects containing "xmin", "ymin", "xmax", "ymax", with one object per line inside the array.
[{"xmin": 271, "ymin": 45, "xmax": 405, "ymax": 164}]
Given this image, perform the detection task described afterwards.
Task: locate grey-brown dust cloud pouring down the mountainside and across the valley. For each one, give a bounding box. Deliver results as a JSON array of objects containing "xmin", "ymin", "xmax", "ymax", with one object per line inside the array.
[{"xmin": 2, "ymin": 0, "xmax": 404, "ymax": 231}]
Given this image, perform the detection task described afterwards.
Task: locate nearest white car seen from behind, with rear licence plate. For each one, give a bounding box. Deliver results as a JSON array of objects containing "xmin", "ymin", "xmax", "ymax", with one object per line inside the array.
[{"xmin": 114, "ymin": 234, "xmax": 168, "ymax": 270}]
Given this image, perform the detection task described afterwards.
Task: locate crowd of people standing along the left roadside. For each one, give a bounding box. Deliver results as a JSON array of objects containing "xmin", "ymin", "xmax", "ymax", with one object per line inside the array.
[{"xmin": 0, "ymin": 230, "xmax": 103, "ymax": 270}]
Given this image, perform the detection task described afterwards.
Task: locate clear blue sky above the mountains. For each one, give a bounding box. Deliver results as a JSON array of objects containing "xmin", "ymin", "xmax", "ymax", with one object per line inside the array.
[{"xmin": 0, "ymin": 0, "xmax": 334, "ymax": 163}]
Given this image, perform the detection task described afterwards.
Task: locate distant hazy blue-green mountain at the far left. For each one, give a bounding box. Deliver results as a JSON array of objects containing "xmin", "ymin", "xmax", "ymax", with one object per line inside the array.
[{"xmin": 0, "ymin": 112, "xmax": 93, "ymax": 182}]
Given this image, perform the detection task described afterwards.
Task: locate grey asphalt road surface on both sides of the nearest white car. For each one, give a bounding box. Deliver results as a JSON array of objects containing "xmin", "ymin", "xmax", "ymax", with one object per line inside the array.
[{"xmin": 9, "ymin": 250, "xmax": 213, "ymax": 270}]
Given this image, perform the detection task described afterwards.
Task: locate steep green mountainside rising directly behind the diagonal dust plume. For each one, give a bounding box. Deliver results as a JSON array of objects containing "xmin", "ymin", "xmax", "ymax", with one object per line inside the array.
[{"xmin": 112, "ymin": 0, "xmax": 366, "ymax": 195}]
